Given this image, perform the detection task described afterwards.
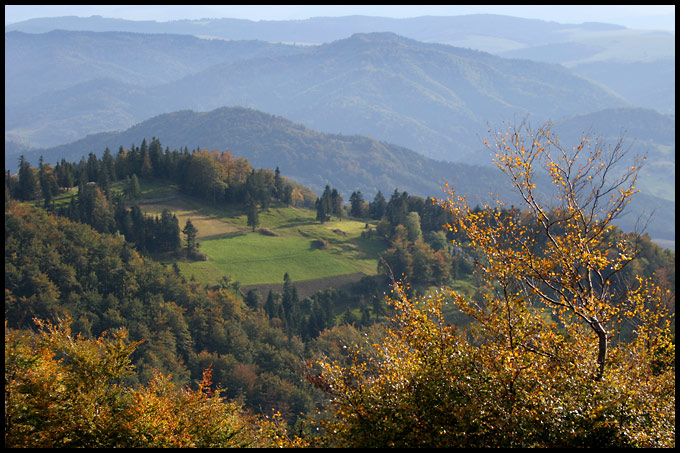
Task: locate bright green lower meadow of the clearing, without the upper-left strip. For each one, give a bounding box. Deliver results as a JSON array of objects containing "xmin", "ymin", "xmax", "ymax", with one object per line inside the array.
[{"xmin": 178, "ymin": 213, "xmax": 385, "ymax": 285}]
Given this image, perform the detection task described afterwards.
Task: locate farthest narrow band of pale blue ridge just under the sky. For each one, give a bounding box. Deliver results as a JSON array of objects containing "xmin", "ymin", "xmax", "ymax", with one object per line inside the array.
[{"xmin": 5, "ymin": 14, "xmax": 625, "ymax": 51}]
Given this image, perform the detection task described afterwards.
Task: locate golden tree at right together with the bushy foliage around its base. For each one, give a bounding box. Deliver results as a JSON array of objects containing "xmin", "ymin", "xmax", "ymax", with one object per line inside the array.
[{"xmin": 308, "ymin": 124, "xmax": 675, "ymax": 447}]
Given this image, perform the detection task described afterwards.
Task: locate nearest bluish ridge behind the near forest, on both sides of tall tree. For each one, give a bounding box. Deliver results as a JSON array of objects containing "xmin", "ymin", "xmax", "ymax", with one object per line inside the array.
[{"xmin": 11, "ymin": 107, "xmax": 675, "ymax": 244}]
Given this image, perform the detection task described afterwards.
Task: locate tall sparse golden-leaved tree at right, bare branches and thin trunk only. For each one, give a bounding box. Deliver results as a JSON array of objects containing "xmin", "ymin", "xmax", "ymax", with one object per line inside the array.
[{"xmin": 452, "ymin": 124, "xmax": 643, "ymax": 379}]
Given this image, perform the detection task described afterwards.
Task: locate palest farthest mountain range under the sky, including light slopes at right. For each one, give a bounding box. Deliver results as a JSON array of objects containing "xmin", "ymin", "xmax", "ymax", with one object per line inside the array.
[{"xmin": 5, "ymin": 14, "xmax": 675, "ymax": 113}]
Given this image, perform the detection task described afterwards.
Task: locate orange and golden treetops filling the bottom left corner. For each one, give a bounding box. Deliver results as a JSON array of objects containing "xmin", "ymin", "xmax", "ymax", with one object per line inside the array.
[{"xmin": 5, "ymin": 321, "xmax": 303, "ymax": 448}]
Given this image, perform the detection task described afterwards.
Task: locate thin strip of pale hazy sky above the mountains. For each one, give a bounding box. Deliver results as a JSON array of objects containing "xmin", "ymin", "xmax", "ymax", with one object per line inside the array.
[{"xmin": 5, "ymin": 5, "xmax": 675, "ymax": 32}]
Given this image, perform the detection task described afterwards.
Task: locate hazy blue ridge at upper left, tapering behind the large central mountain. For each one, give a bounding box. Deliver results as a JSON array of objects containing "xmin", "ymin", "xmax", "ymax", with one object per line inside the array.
[{"xmin": 5, "ymin": 26, "xmax": 303, "ymax": 104}]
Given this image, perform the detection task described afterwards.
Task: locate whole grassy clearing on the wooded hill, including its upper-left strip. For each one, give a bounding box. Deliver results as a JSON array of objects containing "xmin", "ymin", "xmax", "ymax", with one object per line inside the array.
[{"xmin": 131, "ymin": 182, "xmax": 385, "ymax": 285}]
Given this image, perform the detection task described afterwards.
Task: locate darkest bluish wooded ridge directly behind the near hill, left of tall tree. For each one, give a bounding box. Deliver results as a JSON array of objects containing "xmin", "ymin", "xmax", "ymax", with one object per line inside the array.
[{"xmin": 14, "ymin": 107, "xmax": 504, "ymax": 201}]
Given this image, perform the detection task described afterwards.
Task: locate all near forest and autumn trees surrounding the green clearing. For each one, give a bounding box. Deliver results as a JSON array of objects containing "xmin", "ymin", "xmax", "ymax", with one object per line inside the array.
[{"xmin": 5, "ymin": 125, "xmax": 675, "ymax": 446}]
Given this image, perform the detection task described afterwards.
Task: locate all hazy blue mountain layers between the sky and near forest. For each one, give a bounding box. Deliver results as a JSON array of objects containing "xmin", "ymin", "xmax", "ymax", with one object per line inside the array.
[{"xmin": 5, "ymin": 15, "xmax": 675, "ymax": 244}]
